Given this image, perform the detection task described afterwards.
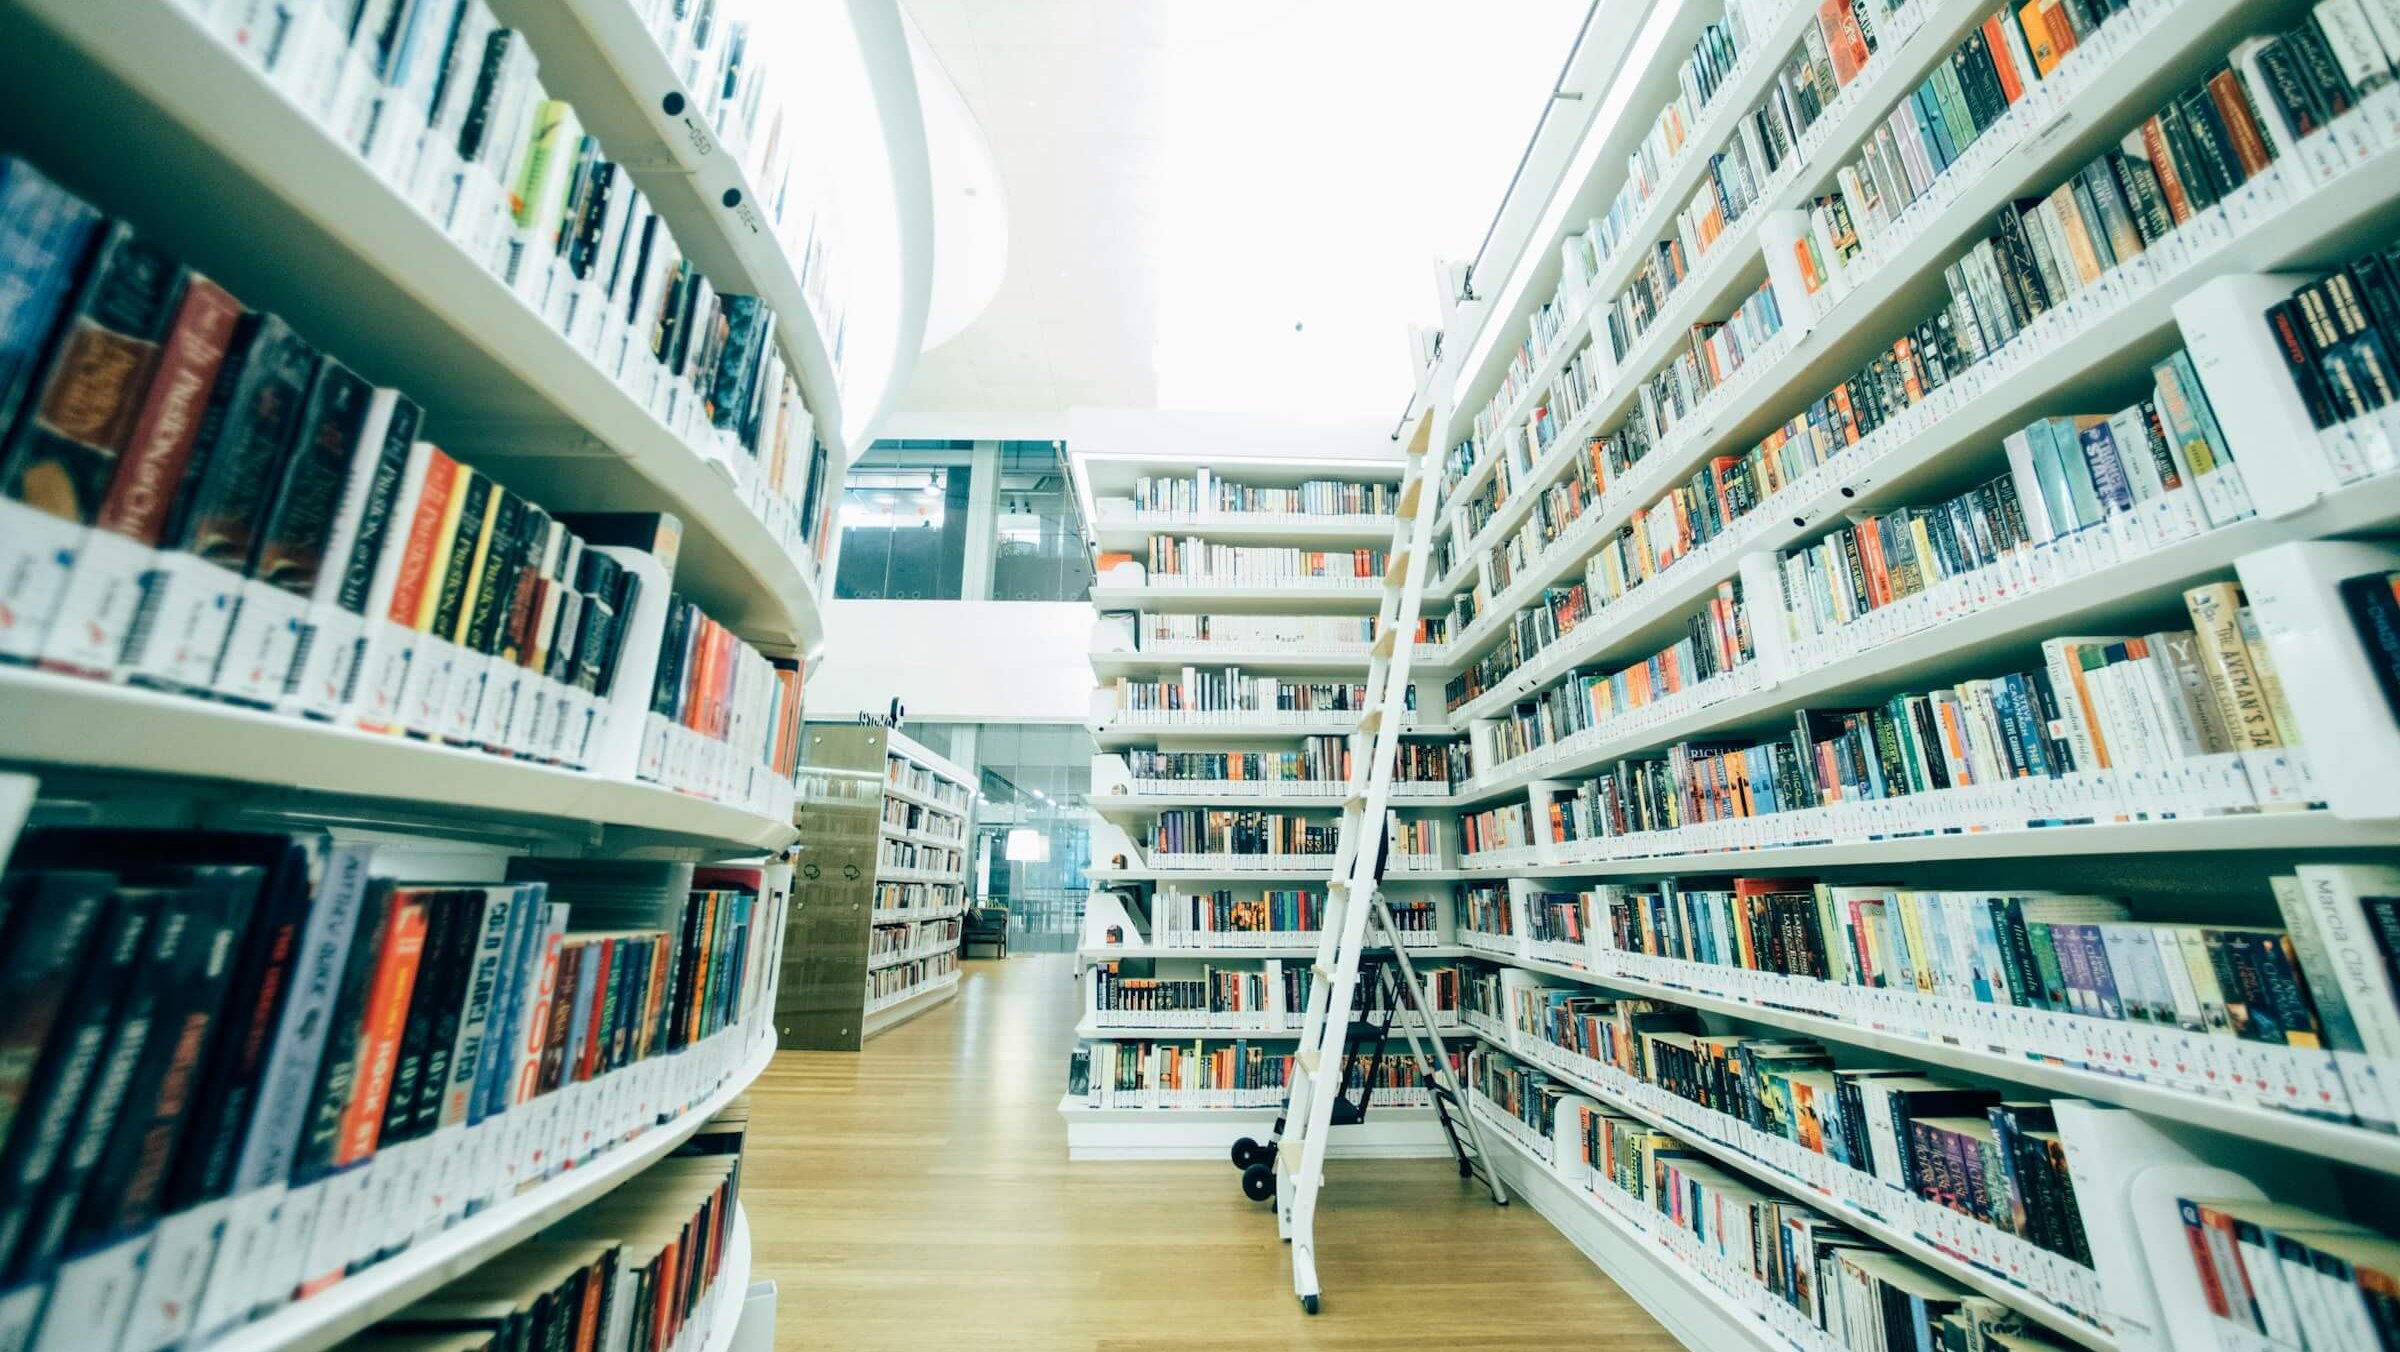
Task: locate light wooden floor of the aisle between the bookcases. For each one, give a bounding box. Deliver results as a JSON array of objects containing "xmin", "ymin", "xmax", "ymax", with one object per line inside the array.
[{"xmin": 742, "ymin": 953, "xmax": 1675, "ymax": 1352}]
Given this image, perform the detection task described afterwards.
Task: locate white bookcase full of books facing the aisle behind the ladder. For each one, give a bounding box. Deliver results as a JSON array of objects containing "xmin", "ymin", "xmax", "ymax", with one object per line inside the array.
[{"xmin": 1061, "ymin": 451, "xmax": 1464, "ymax": 1160}]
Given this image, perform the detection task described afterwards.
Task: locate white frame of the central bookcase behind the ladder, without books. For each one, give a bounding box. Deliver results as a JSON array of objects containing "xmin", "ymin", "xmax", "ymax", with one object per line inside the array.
[{"xmin": 1061, "ymin": 447, "xmax": 1464, "ymax": 1160}]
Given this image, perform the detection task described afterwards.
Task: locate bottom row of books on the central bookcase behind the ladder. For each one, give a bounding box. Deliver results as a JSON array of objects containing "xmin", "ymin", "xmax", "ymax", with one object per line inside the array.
[{"xmin": 1066, "ymin": 1037, "xmax": 1466, "ymax": 1109}]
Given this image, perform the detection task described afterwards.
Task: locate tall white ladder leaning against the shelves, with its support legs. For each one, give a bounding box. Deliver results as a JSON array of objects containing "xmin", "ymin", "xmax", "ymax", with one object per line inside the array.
[{"xmin": 1274, "ymin": 408, "xmax": 1507, "ymax": 1314}]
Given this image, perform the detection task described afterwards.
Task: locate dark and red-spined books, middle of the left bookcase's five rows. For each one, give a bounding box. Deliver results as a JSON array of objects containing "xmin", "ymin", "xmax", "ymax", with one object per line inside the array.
[{"xmin": 0, "ymin": 161, "xmax": 802, "ymax": 809}]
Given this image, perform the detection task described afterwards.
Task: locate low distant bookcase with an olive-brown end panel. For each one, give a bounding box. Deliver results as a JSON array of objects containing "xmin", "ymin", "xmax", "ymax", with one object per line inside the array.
[{"xmin": 785, "ymin": 723, "xmax": 977, "ymax": 1049}]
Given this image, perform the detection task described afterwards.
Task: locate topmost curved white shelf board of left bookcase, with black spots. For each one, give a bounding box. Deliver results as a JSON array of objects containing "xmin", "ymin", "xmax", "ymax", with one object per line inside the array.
[{"xmin": 477, "ymin": 0, "xmax": 852, "ymax": 466}]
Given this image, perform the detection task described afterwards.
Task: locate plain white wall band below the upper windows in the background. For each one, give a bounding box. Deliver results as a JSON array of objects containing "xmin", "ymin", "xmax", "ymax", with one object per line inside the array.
[{"xmin": 806, "ymin": 600, "xmax": 1092, "ymax": 723}]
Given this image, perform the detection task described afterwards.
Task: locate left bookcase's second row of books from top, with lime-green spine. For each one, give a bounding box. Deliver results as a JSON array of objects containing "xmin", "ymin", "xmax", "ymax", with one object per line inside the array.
[{"xmin": 190, "ymin": 0, "xmax": 840, "ymax": 562}]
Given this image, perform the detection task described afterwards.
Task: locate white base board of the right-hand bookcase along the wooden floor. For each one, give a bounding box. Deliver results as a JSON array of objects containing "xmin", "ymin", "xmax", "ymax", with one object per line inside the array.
[{"xmin": 1469, "ymin": 1107, "xmax": 1793, "ymax": 1352}]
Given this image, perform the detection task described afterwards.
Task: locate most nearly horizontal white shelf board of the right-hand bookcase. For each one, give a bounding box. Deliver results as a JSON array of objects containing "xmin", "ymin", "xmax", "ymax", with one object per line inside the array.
[{"xmin": 1450, "ymin": 812, "xmax": 2400, "ymax": 879}]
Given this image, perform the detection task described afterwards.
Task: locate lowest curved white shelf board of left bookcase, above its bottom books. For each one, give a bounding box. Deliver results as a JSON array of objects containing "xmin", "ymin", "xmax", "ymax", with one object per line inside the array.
[{"xmin": 209, "ymin": 1037, "xmax": 775, "ymax": 1352}]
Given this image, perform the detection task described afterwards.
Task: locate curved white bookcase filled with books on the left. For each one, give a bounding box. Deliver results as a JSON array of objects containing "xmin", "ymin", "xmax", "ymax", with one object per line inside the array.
[{"xmin": 0, "ymin": 0, "xmax": 916, "ymax": 1352}]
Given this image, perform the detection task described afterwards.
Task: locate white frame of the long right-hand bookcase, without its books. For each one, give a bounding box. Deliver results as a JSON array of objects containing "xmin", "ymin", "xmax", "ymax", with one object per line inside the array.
[{"xmin": 1363, "ymin": 0, "xmax": 2400, "ymax": 1352}]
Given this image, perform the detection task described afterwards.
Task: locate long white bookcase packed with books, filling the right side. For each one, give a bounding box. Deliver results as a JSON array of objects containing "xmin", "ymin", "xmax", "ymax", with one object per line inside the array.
[{"xmin": 1353, "ymin": 0, "xmax": 2400, "ymax": 1352}]
